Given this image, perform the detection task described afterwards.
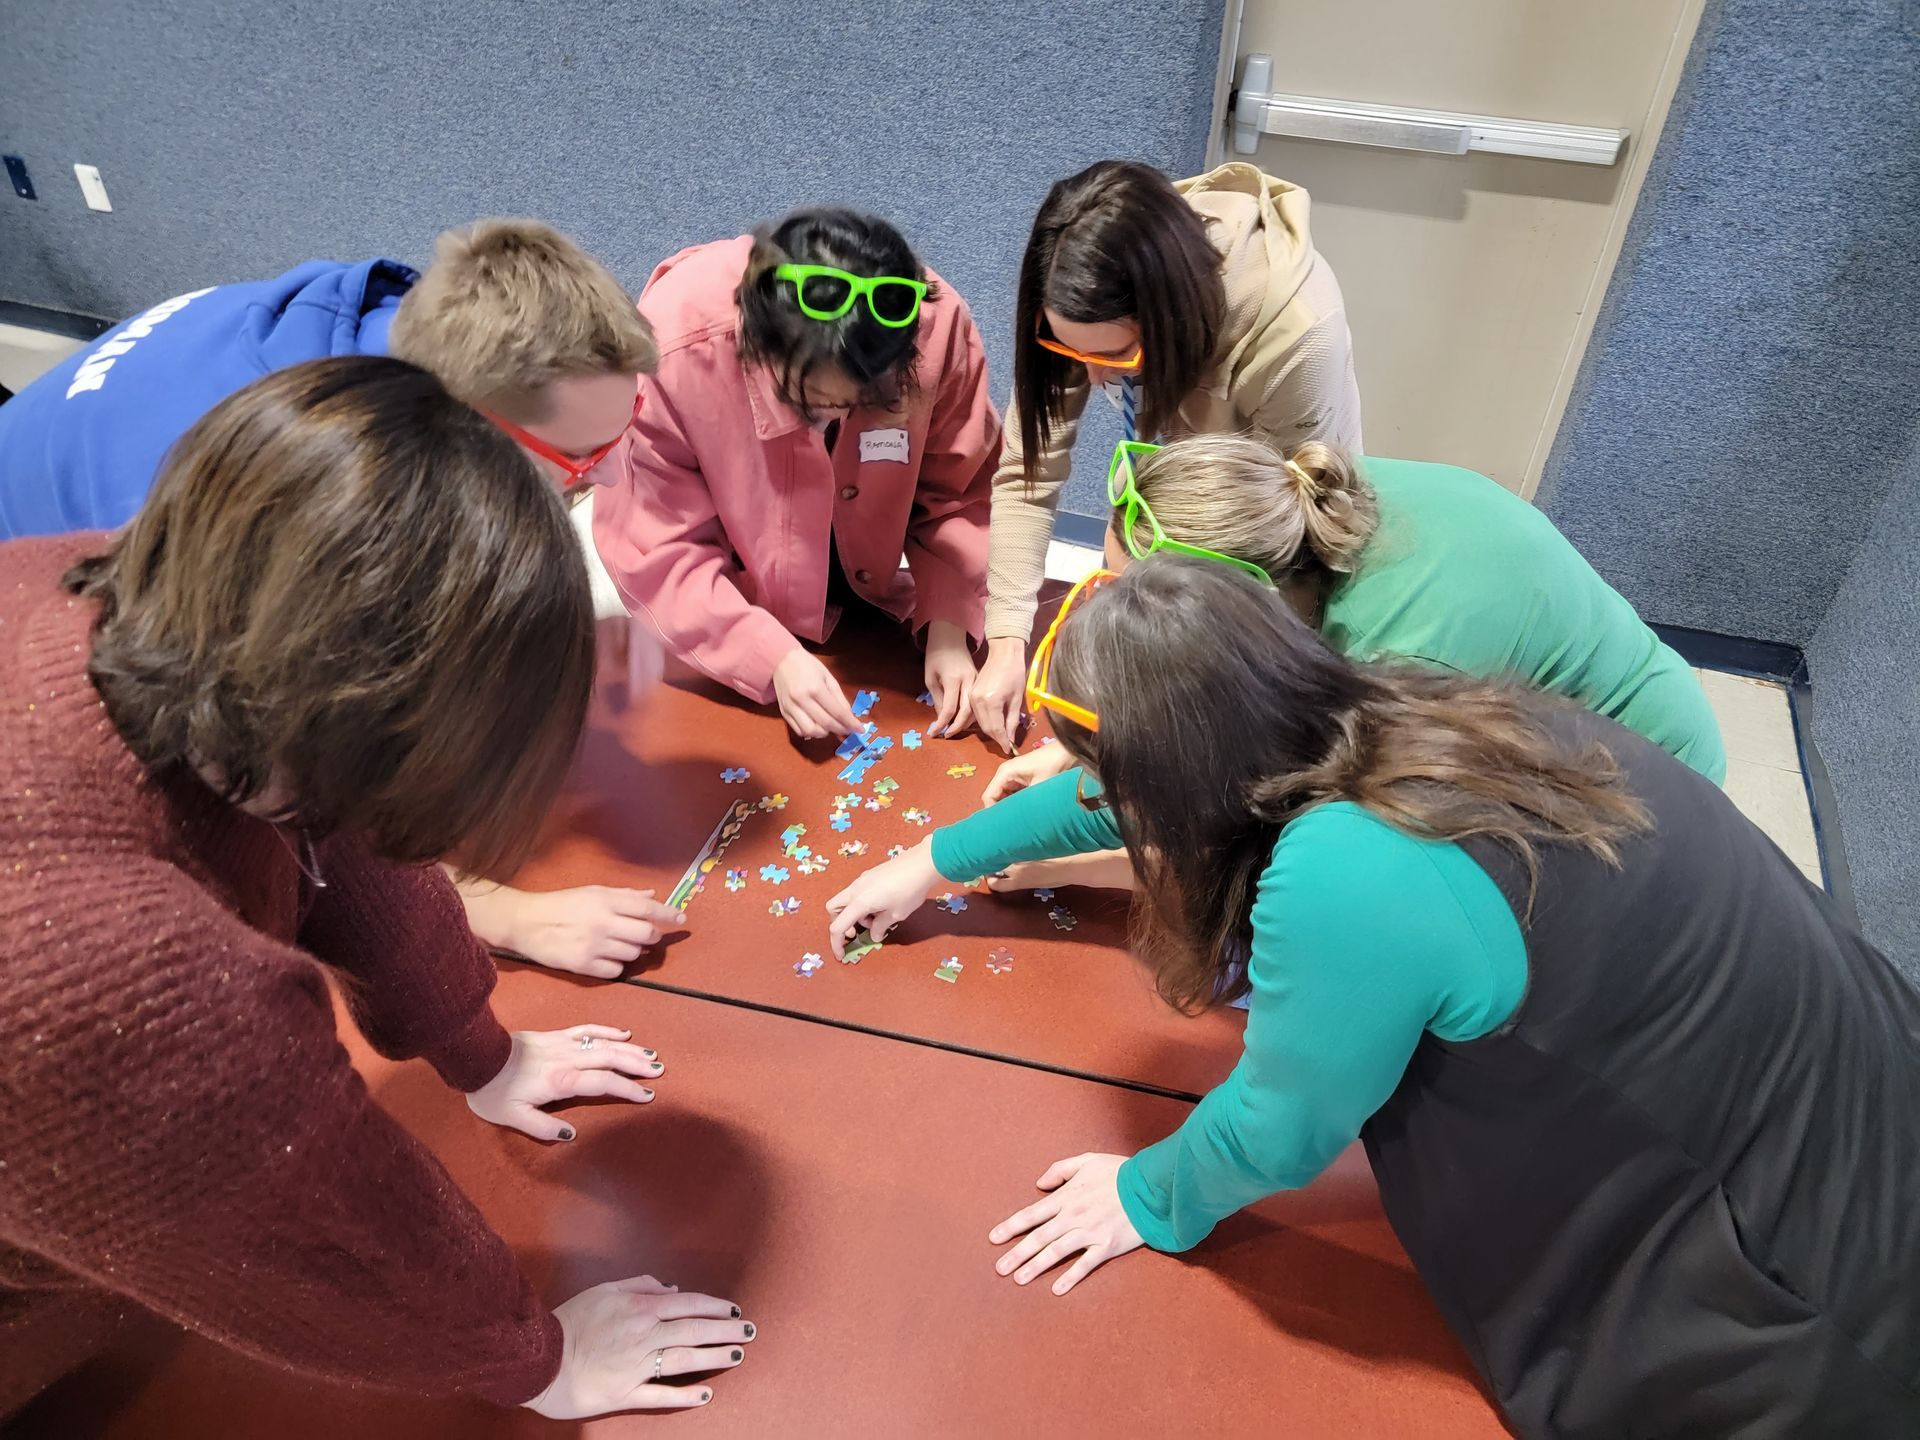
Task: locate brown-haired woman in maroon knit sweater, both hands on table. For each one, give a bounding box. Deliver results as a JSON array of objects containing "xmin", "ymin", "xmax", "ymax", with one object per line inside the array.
[{"xmin": 0, "ymin": 357, "xmax": 753, "ymax": 1417}]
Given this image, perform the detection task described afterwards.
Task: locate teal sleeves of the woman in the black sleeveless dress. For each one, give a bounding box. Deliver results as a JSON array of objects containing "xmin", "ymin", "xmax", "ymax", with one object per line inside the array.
[{"xmin": 933, "ymin": 770, "xmax": 1526, "ymax": 1250}]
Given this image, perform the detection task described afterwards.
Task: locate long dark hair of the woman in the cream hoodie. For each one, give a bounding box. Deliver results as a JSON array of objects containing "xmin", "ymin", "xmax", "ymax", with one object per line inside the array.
[{"xmin": 1014, "ymin": 159, "xmax": 1227, "ymax": 480}]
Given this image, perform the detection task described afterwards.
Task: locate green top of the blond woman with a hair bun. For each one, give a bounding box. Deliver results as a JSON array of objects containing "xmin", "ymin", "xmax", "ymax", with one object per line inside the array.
[{"xmin": 1321, "ymin": 459, "xmax": 1726, "ymax": 783}]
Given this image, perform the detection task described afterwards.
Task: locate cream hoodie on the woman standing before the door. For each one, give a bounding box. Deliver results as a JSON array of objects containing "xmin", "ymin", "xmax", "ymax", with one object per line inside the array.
[{"xmin": 987, "ymin": 161, "xmax": 1361, "ymax": 641}]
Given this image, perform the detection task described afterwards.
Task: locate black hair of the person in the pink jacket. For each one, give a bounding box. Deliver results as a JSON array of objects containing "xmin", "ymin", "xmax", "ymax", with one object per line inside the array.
[{"xmin": 735, "ymin": 205, "xmax": 935, "ymax": 420}]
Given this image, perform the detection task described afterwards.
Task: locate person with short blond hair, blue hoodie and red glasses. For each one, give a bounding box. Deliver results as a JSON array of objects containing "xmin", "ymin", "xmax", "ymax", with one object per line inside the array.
[{"xmin": 0, "ymin": 219, "xmax": 678, "ymax": 979}]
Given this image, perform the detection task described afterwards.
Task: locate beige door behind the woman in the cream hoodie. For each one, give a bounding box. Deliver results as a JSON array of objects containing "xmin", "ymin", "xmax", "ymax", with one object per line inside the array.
[{"xmin": 1213, "ymin": 0, "xmax": 1703, "ymax": 495}]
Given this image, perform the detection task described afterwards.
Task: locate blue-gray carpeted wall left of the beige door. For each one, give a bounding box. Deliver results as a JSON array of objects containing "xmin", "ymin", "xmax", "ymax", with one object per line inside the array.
[{"xmin": 0, "ymin": 0, "xmax": 1223, "ymax": 513}]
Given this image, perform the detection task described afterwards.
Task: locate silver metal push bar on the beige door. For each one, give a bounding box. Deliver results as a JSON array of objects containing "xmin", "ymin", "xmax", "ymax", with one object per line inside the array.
[{"xmin": 1233, "ymin": 56, "xmax": 1628, "ymax": 165}]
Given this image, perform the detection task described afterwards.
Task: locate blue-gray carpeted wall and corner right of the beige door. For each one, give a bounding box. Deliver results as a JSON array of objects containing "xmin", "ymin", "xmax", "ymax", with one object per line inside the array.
[{"xmin": 1540, "ymin": 0, "xmax": 1920, "ymax": 975}]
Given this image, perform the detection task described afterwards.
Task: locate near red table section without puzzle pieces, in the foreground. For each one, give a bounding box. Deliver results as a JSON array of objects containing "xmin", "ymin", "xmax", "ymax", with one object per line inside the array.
[{"xmin": 19, "ymin": 970, "xmax": 1501, "ymax": 1440}]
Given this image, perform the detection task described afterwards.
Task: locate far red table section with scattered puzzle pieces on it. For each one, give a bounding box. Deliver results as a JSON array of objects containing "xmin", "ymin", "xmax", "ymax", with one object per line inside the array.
[{"xmin": 516, "ymin": 618, "xmax": 1242, "ymax": 1096}]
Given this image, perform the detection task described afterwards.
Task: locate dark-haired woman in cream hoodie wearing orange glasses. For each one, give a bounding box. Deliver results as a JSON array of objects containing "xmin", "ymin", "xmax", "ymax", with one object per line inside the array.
[{"xmin": 973, "ymin": 159, "xmax": 1361, "ymax": 751}]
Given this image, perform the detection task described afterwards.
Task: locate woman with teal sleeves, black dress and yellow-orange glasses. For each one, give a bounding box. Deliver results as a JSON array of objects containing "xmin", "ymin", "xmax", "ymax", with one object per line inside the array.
[{"xmin": 829, "ymin": 555, "xmax": 1920, "ymax": 1436}]
